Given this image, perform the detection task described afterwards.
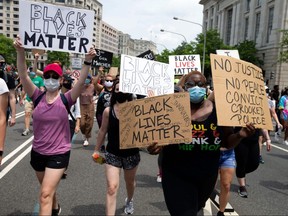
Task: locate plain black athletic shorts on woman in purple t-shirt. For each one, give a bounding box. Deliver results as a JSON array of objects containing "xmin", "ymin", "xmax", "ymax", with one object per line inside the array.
[{"xmin": 30, "ymin": 149, "xmax": 70, "ymax": 172}]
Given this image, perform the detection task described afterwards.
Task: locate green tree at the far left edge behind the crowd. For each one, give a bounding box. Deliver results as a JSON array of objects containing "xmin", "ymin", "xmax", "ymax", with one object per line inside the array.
[{"xmin": 0, "ymin": 35, "xmax": 16, "ymax": 65}]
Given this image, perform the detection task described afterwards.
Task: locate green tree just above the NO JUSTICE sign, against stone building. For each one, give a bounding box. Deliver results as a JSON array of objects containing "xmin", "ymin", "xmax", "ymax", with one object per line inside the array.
[{"xmin": 234, "ymin": 40, "xmax": 263, "ymax": 67}]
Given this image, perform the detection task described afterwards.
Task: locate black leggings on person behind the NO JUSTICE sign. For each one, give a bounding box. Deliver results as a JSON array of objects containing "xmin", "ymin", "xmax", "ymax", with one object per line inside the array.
[{"xmin": 235, "ymin": 140, "xmax": 259, "ymax": 178}]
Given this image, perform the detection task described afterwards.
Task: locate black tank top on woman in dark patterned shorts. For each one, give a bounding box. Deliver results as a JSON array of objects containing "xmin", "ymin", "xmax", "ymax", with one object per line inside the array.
[{"xmin": 106, "ymin": 108, "xmax": 139, "ymax": 157}]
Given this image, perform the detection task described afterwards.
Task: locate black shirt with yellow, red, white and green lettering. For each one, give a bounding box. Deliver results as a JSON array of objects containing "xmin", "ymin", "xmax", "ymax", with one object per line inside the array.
[{"xmin": 162, "ymin": 108, "xmax": 223, "ymax": 181}]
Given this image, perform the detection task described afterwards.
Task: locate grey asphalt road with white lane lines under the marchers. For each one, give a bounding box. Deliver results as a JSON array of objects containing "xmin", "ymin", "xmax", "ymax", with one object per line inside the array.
[{"xmin": 0, "ymin": 104, "xmax": 288, "ymax": 215}]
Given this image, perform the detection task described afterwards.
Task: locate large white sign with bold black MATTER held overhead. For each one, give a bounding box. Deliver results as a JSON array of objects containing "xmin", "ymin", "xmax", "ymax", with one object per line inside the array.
[{"xmin": 19, "ymin": 1, "xmax": 94, "ymax": 53}]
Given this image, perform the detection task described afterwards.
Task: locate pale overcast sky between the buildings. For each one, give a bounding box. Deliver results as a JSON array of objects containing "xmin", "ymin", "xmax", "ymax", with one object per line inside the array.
[{"xmin": 99, "ymin": 0, "xmax": 203, "ymax": 52}]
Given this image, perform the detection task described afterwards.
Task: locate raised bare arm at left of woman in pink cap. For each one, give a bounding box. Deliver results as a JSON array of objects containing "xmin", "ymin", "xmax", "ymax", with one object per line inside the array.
[{"xmin": 14, "ymin": 37, "xmax": 37, "ymax": 97}]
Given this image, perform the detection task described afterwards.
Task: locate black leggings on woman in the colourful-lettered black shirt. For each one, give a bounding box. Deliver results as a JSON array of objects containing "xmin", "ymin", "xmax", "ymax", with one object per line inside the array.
[{"xmin": 162, "ymin": 167, "xmax": 218, "ymax": 216}]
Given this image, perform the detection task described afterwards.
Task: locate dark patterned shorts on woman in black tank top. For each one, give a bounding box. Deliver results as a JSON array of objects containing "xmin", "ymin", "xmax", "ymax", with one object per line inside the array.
[{"xmin": 105, "ymin": 152, "xmax": 140, "ymax": 170}]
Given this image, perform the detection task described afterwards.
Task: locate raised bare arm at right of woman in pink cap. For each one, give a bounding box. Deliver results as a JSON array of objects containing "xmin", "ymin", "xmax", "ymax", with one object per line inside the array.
[{"xmin": 71, "ymin": 47, "xmax": 96, "ymax": 101}]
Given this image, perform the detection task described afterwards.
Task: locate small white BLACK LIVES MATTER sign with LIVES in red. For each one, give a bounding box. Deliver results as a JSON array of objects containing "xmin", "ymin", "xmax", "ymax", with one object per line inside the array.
[{"xmin": 169, "ymin": 55, "xmax": 201, "ymax": 75}]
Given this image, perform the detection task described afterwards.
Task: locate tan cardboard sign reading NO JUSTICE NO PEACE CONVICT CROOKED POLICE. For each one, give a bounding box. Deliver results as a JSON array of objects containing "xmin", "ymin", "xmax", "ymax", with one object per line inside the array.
[{"xmin": 210, "ymin": 54, "xmax": 273, "ymax": 130}]
